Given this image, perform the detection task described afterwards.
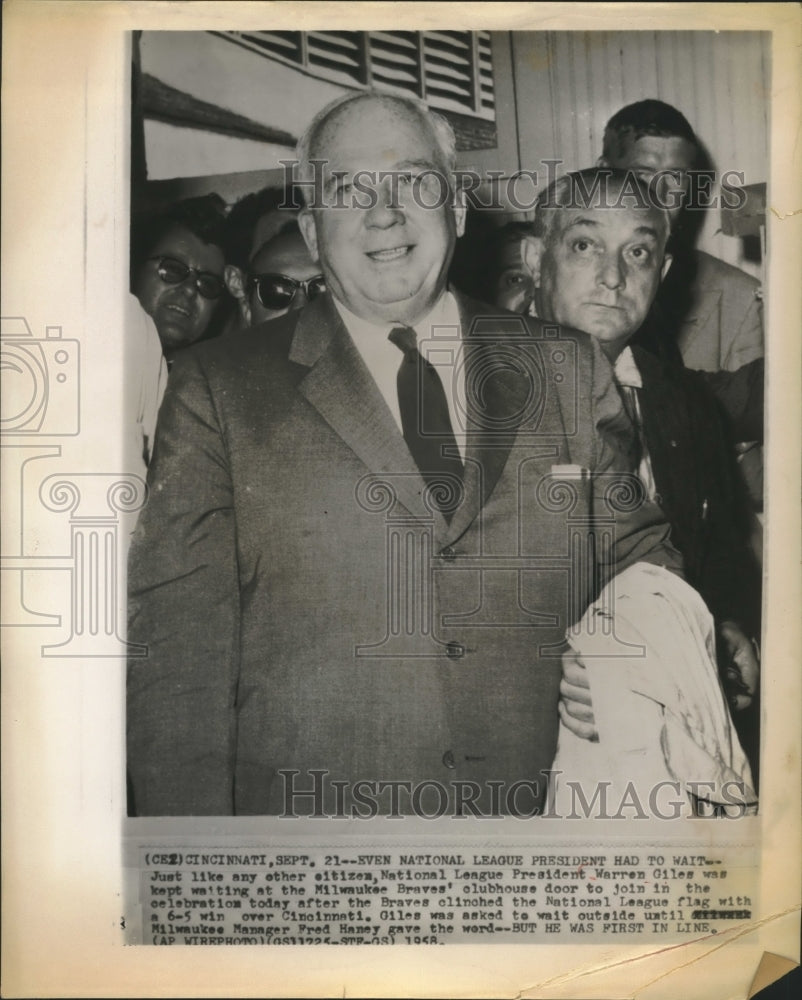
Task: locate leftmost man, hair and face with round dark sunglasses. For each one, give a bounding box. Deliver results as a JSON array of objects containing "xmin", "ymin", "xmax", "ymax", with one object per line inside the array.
[{"xmin": 131, "ymin": 195, "xmax": 227, "ymax": 362}]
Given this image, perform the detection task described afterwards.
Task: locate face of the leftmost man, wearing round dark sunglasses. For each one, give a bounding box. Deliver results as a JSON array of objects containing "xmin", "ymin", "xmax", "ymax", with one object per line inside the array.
[{"xmin": 134, "ymin": 225, "xmax": 224, "ymax": 357}]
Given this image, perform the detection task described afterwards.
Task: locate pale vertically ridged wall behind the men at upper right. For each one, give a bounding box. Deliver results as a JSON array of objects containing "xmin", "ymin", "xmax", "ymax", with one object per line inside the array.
[{"xmin": 511, "ymin": 31, "xmax": 770, "ymax": 272}]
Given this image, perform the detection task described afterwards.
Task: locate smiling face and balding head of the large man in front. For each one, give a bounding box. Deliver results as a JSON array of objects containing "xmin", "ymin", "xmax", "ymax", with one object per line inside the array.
[{"xmin": 299, "ymin": 97, "xmax": 464, "ymax": 325}]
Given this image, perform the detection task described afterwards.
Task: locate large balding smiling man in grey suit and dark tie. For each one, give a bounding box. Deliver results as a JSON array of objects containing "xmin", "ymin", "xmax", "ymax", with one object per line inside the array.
[{"xmin": 127, "ymin": 94, "xmax": 681, "ymax": 816}]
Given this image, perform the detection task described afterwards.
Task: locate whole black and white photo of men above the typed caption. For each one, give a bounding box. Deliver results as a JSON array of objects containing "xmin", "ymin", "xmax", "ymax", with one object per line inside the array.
[{"xmin": 127, "ymin": 31, "xmax": 770, "ymax": 816}]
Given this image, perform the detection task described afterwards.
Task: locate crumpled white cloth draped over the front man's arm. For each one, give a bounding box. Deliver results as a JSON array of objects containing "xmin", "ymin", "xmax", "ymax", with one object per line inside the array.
[{"xmin": 553, "ymin": 563, "xmax": 757, "ymax": 815}]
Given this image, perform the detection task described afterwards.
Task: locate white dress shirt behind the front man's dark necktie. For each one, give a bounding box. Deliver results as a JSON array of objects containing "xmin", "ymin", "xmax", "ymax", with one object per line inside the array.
[{"xmin": 334, "ymin": 292, "xmax": 465, "ymax": 462}]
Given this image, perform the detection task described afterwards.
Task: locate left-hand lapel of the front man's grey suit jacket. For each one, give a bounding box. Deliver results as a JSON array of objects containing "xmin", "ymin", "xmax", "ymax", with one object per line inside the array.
[{"xmin": 289, "ymin": 296, "xmax": 446, "ymax": 537}]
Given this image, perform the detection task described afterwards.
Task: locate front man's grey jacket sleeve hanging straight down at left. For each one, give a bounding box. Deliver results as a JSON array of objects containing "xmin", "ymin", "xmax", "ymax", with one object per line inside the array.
[{"xmin": 126, "ymin": 351, "xmax": 239, "ymax": 815}]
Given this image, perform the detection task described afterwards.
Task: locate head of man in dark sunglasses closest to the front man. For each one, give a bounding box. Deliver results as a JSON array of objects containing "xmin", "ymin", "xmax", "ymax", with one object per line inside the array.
[{"xmin": 220, "ymin": 188, "xmax": 326, "ymax": 329}]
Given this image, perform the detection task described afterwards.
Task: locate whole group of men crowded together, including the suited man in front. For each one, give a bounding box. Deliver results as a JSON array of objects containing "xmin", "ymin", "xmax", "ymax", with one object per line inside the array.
[{"xmin": 127, "ymin": 93, "xmax": 763, "ymax": 815}]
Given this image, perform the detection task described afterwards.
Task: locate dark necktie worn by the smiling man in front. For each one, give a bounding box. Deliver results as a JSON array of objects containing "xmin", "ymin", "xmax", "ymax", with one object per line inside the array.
[{"xmin": 389, "ymin": 326, "xmax": 463, "ymax": 520}]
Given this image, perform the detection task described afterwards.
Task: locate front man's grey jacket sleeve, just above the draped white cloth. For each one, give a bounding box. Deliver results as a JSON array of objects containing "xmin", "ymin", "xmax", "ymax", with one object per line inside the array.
[{"xmin": 590, "ymin": 338, "xmax": 684, "ymax": 588}]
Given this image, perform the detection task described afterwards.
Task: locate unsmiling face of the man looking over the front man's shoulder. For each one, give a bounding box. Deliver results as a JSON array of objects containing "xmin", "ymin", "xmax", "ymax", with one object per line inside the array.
[{"xmin": 524, "ymin": 207, "xmax": 671, "ymax": 358}]
